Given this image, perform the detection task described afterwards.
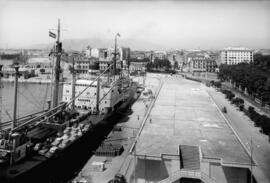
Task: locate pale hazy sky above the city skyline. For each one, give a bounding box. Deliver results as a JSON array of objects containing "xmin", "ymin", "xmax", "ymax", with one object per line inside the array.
[{"xmin": 0, "ymin": 0, "xmax": 270, "ymax": 49}]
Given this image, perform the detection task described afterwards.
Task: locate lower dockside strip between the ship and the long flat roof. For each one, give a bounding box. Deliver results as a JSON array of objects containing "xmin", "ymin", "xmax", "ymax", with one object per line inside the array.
[{"xmin": 71, "ymin": 74, "xmax": 165, "ymax": 182}]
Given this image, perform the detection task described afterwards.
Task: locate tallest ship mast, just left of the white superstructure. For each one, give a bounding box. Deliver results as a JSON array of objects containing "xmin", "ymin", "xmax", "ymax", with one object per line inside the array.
[{"xmin": 53, "ymin": 19, "xmax": 62, "ymax": 108}]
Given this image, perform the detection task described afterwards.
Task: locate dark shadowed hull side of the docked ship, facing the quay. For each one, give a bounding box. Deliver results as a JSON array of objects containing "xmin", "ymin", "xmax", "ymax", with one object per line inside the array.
[{"xmin": 0, "ymin": 83, "xmax": 137, "ymax": 183}]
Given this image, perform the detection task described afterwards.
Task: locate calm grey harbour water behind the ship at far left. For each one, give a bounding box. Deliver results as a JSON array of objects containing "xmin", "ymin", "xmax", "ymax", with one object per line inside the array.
[{"xmin": 1, "ymin": 83, "xmax": 62, "ymax": 121}]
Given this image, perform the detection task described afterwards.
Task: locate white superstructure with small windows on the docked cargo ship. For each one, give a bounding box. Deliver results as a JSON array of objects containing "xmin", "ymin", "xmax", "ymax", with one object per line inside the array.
[{"xmin": 62, "ymin": 78, "xmax": 130, "ymax": 114}]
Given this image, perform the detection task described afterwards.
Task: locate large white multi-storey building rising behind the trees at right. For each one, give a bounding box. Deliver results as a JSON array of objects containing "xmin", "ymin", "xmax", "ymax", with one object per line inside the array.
[{"xmin": 220, "ymin": 48, "xmax": 253, "ymax": 65}]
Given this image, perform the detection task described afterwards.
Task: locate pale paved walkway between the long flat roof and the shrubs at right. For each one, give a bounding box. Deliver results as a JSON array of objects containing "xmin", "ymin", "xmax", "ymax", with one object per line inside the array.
[{"xmin": 205, "ymin": 87, "xmax": 270, "ymax": 183}]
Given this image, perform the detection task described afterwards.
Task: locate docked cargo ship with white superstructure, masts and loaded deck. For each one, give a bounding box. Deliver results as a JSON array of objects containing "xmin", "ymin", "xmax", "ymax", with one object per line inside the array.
[{"xmin": 0, "ymin": 21, "xmax": 136, "ymax": 183}]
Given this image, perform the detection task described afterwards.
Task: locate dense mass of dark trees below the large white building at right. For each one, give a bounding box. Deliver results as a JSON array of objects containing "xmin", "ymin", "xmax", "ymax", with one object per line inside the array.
[{"xmin": 218, "ymin": 54, "xmax": 270, "ymax": 103}]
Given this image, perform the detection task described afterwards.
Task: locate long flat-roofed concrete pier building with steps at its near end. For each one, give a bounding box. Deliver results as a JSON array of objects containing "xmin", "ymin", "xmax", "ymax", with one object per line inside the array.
[{"xmin": 129, "ymin": 76, "xmax": 254, "ymax": 182}]
